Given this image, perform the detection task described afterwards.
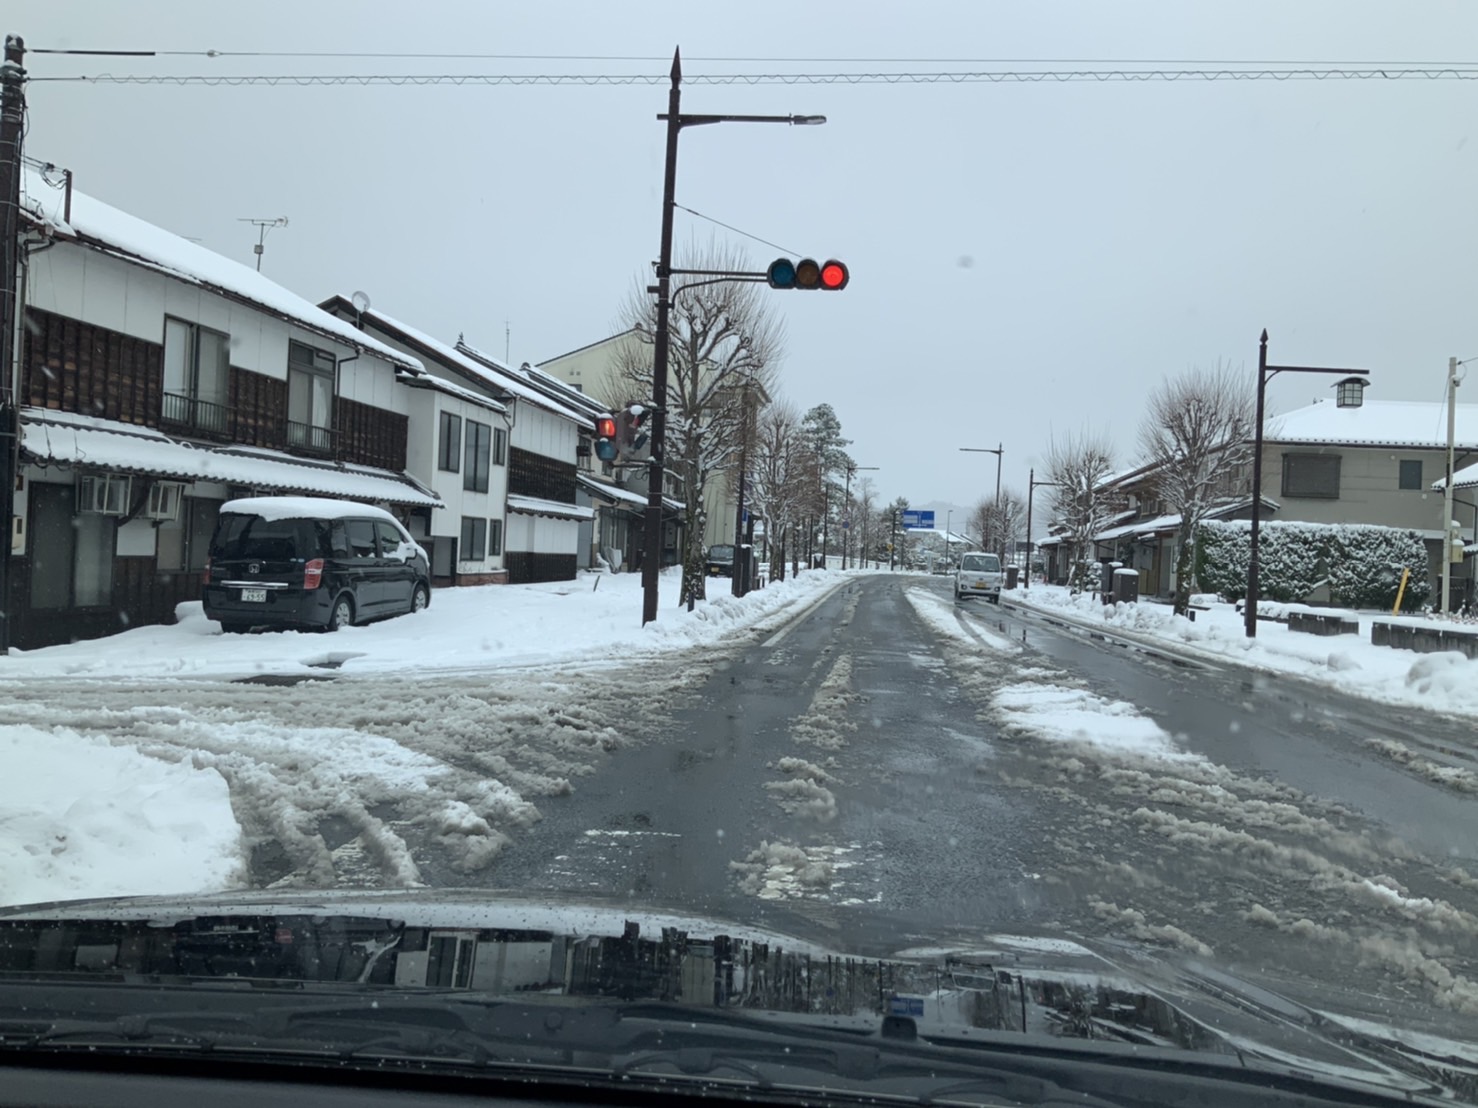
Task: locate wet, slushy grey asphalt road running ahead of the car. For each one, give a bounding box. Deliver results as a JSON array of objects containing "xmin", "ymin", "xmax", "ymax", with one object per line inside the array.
[{"xmin": 478, "ymin": 575, "xmax": 1478, "ymax": 1010}]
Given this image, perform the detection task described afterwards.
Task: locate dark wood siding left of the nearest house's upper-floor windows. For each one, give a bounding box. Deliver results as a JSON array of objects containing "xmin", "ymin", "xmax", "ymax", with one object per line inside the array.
[{"xmin": 21, "ymin": 307, "xmax": 164, "ymax": 427}]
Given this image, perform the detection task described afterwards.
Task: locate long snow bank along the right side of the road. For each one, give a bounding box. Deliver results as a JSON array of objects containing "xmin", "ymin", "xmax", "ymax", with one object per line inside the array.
[{"xmin": 1008, "ymin": 585, "xmax": 1478, "ymax": 715}]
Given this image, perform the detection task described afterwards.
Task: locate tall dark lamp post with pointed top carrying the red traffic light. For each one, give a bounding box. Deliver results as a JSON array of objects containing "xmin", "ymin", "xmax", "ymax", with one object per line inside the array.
[{"xmin": 641, "ymin": 50, "xmax": 826, "ymax": 623}]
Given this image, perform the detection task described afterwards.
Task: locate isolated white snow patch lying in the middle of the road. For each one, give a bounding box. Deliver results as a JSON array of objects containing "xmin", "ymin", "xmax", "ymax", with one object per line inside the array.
[{"xmin": 992, "ymin": 683, "xmax": 1202, "ymax": 762}]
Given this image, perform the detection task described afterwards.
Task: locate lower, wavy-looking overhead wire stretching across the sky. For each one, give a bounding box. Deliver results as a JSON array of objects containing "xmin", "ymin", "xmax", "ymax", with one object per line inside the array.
[{"xmin": 28, "ymin": 66, "xmax": 1478, "ymax": 87}]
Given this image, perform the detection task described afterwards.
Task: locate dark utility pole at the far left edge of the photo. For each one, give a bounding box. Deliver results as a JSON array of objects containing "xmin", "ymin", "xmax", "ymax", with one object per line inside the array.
[{"xmin": 0, "ymin": 34, "xmax": 25, "ymax": 656}]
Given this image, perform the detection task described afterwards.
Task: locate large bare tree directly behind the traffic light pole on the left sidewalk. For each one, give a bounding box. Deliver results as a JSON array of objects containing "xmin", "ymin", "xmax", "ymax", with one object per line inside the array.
[{"xmin": 616, "ymin": 242, "xmax": 785, "ymax": 604}]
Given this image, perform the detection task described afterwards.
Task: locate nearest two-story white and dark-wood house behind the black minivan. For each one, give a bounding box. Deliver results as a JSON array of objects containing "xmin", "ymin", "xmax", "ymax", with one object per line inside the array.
[{"xmin": 4, "ymin": 171, "xmax": 439, "ymax": 647}]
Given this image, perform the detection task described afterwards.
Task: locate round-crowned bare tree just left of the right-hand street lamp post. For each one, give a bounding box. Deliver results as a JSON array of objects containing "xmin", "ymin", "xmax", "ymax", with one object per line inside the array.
[{"xmin": 1140, "ymin": 362, "xmax": 1256, "ymax": 615}]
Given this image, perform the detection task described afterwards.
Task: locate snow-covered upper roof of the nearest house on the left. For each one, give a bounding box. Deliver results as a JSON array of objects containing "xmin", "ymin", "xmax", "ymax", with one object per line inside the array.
[{"xmin": 21, "ymin": 165, "xmax": 421, "ymax": 369}]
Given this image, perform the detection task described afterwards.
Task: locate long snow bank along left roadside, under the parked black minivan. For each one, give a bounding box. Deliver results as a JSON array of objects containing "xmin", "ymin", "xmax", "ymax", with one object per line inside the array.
[{"xmin": 4, "ymin": 570, "xmax": 848, "ymax": 680}]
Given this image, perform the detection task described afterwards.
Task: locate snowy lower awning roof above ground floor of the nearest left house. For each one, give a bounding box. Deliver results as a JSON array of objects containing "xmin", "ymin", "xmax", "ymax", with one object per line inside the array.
[{"xmin": 21, "ymin": 408, "xmax": 440, "ymax": 507}]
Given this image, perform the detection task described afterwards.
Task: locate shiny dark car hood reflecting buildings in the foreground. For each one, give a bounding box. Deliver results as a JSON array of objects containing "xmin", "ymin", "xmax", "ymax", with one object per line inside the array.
[{"xmin": 0, "ymin": 889, "xmax": 1478, "ymax": 1101}]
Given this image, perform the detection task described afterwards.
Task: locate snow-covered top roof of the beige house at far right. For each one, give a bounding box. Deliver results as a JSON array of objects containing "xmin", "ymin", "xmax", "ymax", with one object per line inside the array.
[{"xmin": 1262, "ymin": 399, "xmax": 1478, "ymax": 451}]
